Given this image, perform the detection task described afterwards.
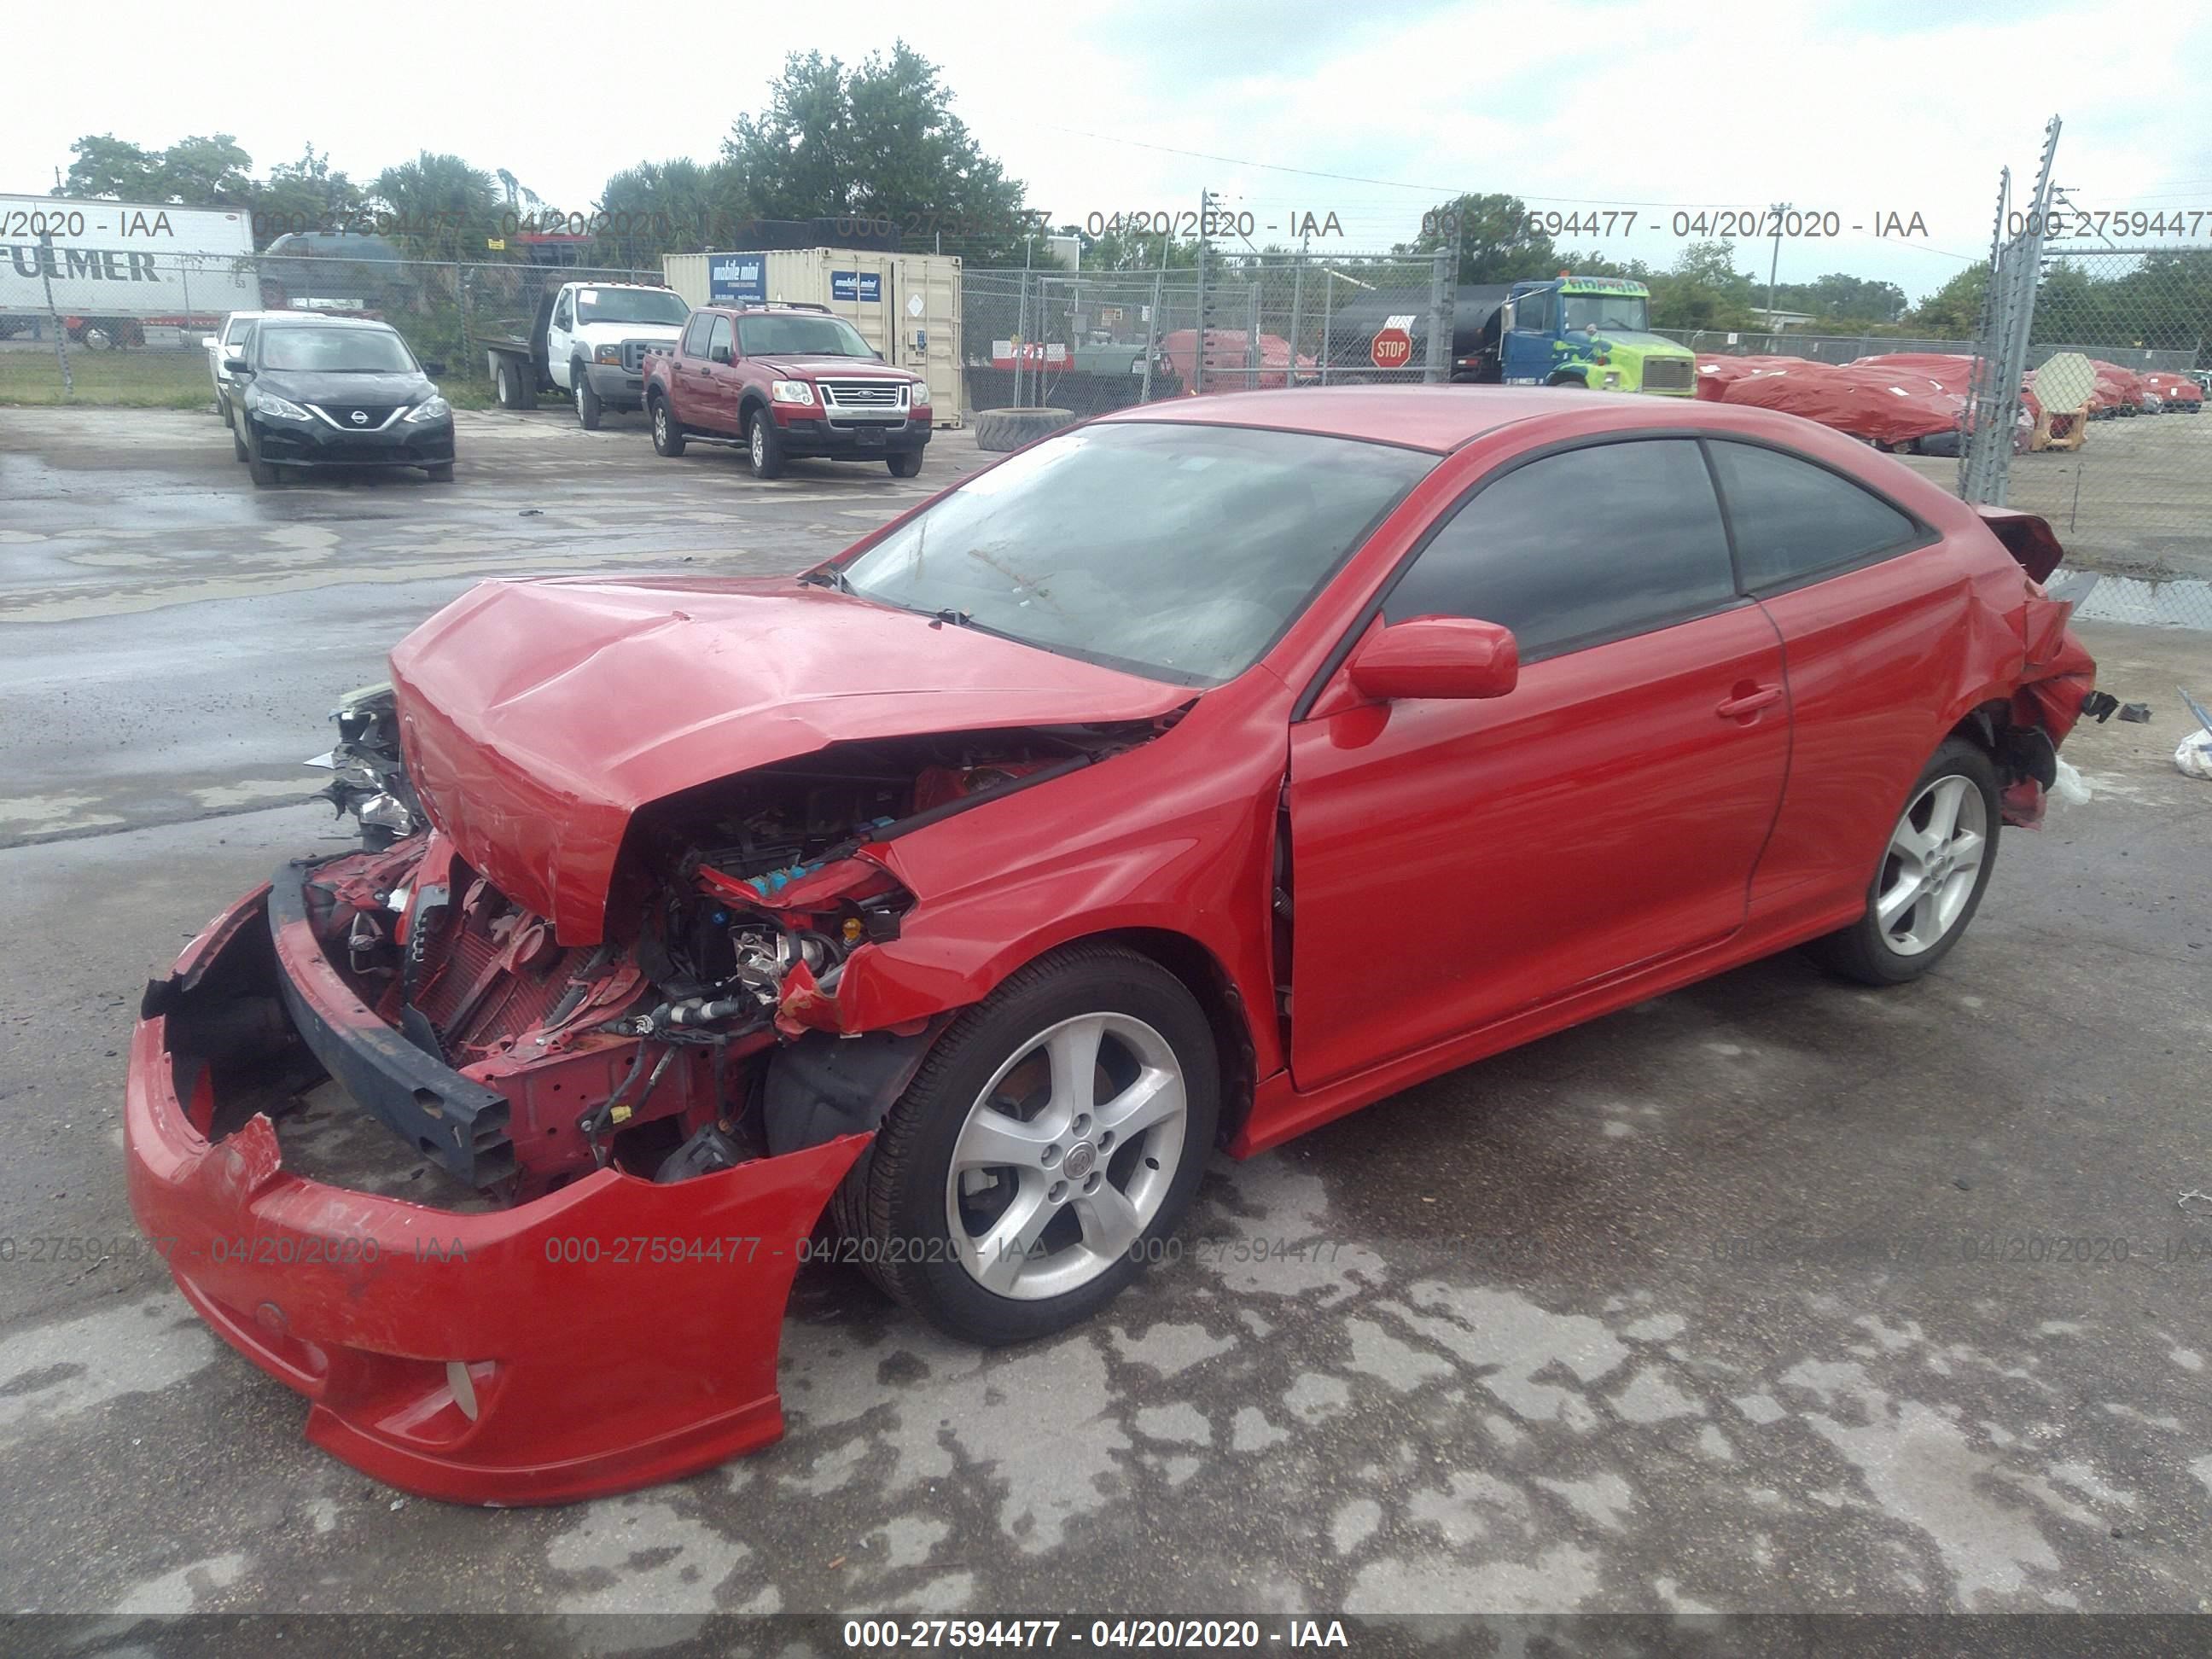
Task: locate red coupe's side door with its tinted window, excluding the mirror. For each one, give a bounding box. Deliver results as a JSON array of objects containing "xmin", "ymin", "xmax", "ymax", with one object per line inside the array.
[{"xmin": 1289, "ymin": 438, "xmax": 1790, "ymax": 1088}]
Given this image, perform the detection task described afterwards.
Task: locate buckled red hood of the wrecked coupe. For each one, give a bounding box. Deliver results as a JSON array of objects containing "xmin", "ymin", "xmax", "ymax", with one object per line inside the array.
[{"xmin": 392, "ymin": 578, "xmax": 1192, "ymax": 945}]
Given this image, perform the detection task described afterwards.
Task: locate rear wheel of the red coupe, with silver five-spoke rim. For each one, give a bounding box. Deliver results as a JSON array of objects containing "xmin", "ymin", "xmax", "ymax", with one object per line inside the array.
[{"xmin": 1805, "ymin": 736, "xmax": 2000, "ymax": 984}]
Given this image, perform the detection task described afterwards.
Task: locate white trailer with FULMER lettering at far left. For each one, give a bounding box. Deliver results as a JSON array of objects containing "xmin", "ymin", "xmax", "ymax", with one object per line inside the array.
[{"xmin": 0, "ymin": 195, "xmax": 261, "ymax": 332}]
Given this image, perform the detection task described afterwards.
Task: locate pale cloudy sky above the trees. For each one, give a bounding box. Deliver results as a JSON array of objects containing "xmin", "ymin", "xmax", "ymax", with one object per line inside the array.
[{"xmin": 0, "ymin": 0, "xmax": 2212, "ymax": 296}]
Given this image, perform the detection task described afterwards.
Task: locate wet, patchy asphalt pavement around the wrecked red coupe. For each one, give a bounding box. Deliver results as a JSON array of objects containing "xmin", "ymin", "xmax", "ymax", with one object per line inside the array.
[{"xmin": 0, "ymin": 411, "xmax": 2212, "ymax": 1645}]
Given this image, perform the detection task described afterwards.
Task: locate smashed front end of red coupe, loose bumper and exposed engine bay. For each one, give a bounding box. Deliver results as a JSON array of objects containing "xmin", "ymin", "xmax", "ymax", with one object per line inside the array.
[{"xmin": 126, "ymin": 692, "xmax": 1155, "ymax": 1505}]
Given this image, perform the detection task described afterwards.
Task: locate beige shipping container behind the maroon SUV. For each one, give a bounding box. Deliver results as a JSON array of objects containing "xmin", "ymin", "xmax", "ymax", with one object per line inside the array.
[{"xmin": 661, "ymin": 247, "xmax": 960, "ymax": 427}]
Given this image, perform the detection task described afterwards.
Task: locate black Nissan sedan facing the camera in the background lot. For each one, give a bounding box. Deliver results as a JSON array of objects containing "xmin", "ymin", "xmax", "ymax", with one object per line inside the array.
[{"xmin": 225, "ymin": 317, "xmax": 453, "ymax": 485}]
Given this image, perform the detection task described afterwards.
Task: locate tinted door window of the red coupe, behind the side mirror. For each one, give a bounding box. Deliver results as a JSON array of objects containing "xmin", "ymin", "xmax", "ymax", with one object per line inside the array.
[{"xmin": 1382, "ymin": 438, "xmax": 1737, "ymax": 661}]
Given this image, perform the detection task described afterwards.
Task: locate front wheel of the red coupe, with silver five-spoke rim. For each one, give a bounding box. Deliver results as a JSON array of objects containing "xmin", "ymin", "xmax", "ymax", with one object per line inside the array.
[{"xmin": 841, "ymin": 945, "xmax": 1221, "ymax": 1345}]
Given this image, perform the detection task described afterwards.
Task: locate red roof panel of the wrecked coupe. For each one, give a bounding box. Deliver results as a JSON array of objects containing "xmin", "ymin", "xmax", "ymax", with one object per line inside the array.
[{"xmin": 1102, "ymin": 382, "xmax": 1902, "ymax": 456}]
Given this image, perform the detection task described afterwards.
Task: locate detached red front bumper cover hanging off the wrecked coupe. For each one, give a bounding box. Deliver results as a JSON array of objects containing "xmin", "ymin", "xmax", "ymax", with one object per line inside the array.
[{"xmin": 124, "ymin": 887, "xmax": 870, "ymax": 1506}]
